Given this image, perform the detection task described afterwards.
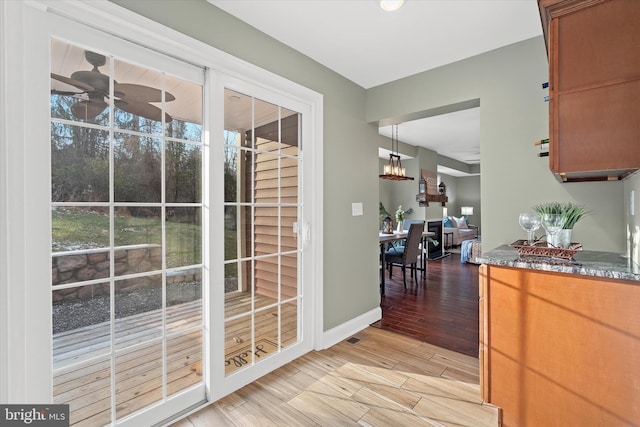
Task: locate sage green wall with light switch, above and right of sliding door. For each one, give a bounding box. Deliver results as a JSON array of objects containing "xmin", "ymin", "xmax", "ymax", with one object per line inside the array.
[{"xmin": 114, "ymin": 0, "xmax": 385, "ymax": 331}]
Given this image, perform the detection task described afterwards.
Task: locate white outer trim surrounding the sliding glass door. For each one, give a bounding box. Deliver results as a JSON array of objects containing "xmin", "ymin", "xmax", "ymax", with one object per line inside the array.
[{"xmin": 0, "ymin": 0, "xmax": 323, "ymax": 414}]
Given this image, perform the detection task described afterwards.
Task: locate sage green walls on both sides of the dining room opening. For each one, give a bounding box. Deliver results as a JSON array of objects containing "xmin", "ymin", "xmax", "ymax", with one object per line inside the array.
[{"xmin": 113, "ymin": 0, "xmax": 637, "ymax": 331}]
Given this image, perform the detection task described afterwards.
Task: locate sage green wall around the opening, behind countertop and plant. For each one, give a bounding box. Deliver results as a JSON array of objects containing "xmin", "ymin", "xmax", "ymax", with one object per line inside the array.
[{"xmin": 367, "ymin": 36, "xmax": 626, "ymax": 252}]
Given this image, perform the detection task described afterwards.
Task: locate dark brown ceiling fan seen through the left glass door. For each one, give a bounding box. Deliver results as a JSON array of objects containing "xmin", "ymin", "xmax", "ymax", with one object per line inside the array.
[{"xmin": 51, "ymin": 50, "xmax": 176, "ymax": 123}]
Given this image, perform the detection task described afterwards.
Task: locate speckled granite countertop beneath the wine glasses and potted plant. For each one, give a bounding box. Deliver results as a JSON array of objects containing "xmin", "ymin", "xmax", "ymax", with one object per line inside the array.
[{"xmin": 477, "ymin": 245, "xmax": 640, "ymax": 284}]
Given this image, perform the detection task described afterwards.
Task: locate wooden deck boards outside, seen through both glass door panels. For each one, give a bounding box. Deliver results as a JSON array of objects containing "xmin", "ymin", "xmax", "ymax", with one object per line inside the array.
[{"xmin": 53, "ymin": 293, "xmax": 297, "ymax": 427}]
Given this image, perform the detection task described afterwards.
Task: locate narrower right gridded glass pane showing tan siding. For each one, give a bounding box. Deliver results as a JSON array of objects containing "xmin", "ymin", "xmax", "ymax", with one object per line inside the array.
[{"xmin": 224, "ymin": 89, "xmax": 301, "ymax": 375}]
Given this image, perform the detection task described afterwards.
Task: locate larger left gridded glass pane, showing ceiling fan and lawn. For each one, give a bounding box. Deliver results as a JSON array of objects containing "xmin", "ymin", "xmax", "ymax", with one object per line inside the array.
[{"xmin": 50, "ymin": 40, "xmax": 204, "ymax": 426}]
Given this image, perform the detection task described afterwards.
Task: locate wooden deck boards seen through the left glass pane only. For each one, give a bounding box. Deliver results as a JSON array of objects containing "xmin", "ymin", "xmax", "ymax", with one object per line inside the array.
[{"xmin": 53, "ymin": 300, "xmax": 202, "ymax": 426}]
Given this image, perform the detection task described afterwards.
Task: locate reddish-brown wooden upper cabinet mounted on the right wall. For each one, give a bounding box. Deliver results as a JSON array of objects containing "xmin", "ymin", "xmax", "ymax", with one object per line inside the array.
[{"xmin": 538, "ymin": 0, "xmax": 640, "ymax": 182}]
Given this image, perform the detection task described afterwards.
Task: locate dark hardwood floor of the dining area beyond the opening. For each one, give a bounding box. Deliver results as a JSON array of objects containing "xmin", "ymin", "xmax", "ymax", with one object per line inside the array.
[{"xmin": 372, "ymin": 254, "xmax": 478, "ymax": 357}]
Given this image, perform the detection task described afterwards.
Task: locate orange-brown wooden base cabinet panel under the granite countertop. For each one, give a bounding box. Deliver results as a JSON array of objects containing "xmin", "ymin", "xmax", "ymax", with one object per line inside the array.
[{"xmin": 479, "ymin": 265, "xmax": 640, "ymax": 427}]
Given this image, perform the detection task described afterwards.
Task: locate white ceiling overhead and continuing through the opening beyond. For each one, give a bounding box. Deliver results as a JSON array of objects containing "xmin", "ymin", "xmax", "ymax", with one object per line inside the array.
[{"xmin": 207, "ymin": 0, "xmax": 542, "ymax": 174}]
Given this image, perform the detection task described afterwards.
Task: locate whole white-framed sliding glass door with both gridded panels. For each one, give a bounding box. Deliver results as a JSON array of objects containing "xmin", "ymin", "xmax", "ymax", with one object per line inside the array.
[{"xmin": 6, "ymin": 0, "xmax": 322, "ymax": 426}]
